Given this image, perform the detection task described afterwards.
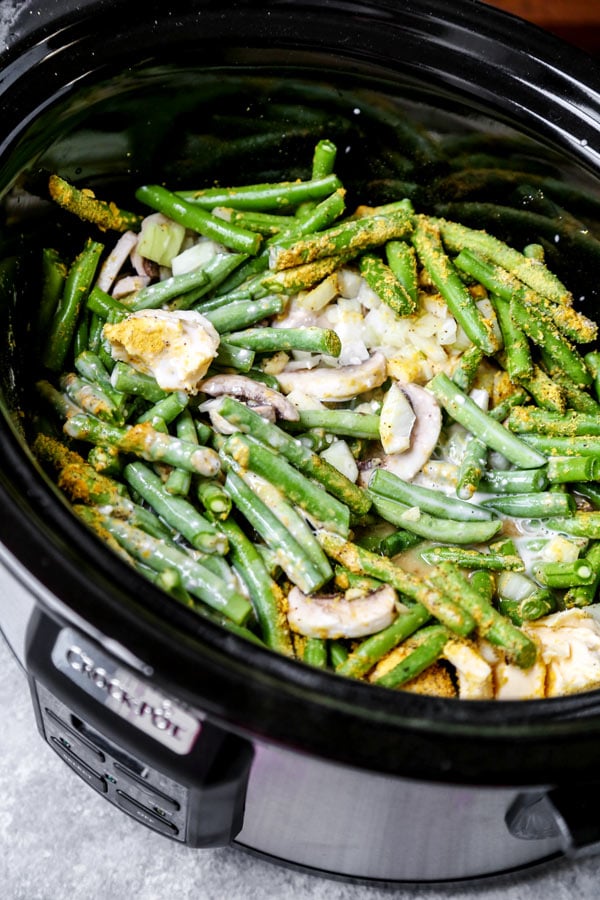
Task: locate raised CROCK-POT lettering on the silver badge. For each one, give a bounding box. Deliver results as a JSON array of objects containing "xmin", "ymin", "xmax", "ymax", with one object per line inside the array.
[{"xmin": 66, "ymin": 646, "xmax": 185, "ymax": 739}]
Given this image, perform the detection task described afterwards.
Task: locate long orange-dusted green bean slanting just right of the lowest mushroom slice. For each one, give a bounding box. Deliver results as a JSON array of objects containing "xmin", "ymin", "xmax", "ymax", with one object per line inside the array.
[{"xmin": 317, "ymin": 531, "xmax": 475, "ymax": 635}]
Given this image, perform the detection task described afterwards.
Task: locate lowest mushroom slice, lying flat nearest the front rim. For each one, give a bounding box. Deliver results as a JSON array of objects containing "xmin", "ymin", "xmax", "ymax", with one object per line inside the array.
[{"xmin": 288, "ymin": 585, "xmax": 397, "ymax": 640}]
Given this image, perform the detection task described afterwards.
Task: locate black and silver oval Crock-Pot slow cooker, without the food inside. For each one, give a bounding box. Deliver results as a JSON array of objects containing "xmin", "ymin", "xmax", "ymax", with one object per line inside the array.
[{"xmin": 0, "ymin": 0, "xmax": 600, "ymax": 884}]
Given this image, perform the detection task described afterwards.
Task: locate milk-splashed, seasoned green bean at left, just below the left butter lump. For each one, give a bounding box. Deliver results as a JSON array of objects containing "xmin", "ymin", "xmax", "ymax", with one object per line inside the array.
[{"xmin": 64, "ymin": 413, "xmax": 220, "ymax": 476}]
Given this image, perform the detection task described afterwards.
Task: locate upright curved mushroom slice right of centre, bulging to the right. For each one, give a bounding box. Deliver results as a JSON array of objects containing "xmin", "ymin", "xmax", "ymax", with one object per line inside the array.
[{"xmin": 381, "ymin": 384, "xmax": 442, "ymax": 481}]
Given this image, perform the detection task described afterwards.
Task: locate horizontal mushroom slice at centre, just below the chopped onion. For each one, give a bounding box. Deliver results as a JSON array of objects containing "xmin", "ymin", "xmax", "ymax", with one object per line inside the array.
[{"xmin": 277, "ymin": 352, "xmax": 387, "ymax": 402}]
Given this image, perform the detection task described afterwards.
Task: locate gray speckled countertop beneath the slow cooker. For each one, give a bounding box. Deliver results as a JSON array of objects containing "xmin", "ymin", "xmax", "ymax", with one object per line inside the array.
[{"xmin": 0, "ymin": 0, "xmax": 600, "ymax": 900}]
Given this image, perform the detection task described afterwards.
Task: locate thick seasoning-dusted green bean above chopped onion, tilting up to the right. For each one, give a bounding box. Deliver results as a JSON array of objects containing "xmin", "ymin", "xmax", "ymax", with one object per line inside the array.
[{"xmin": 269, "ymin": 209, "xmax": 412, "ymax": 272}]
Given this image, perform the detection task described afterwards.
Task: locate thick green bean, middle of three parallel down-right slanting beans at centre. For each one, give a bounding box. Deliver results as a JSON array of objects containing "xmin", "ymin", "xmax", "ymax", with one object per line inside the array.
[{"xmin": 223, "ymin": 433, "xmax": 350, "ymax": 536}]
